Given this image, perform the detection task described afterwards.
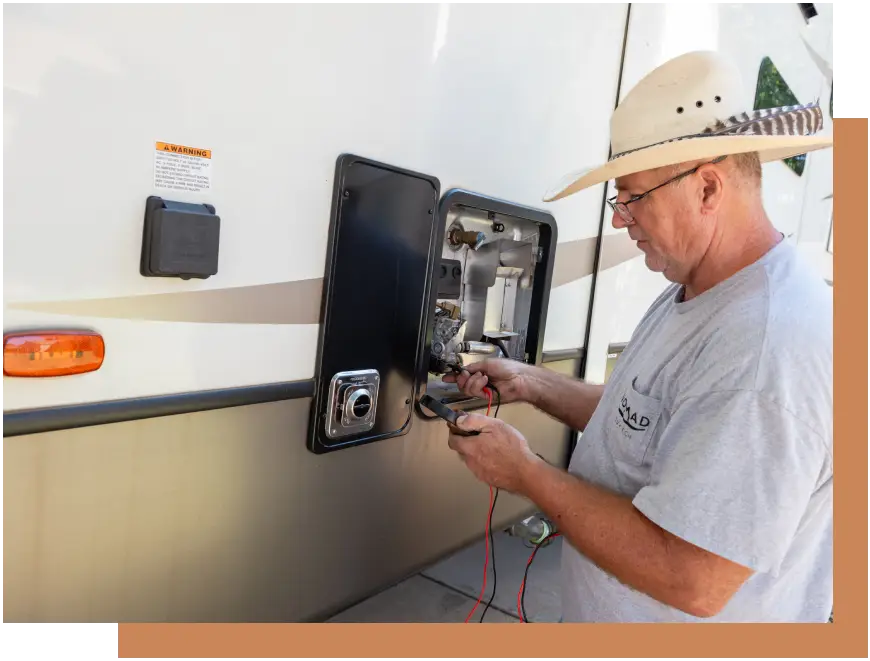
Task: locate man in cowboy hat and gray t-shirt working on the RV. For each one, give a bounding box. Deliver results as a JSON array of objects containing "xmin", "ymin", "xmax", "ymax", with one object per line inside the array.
[{"xmin": 445, "ymin": 52, "xmax": 833, "ymax": 622}]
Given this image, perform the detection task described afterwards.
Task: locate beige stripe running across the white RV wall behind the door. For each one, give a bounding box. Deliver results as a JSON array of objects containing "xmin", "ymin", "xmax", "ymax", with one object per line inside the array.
[{"xmin": 9, "ymin": 233, "xmax": 642, "ymax": 324}]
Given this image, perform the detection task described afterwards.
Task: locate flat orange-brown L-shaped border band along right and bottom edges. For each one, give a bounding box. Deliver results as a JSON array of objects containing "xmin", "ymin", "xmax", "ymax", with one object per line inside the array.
[{"xmin": 118, "ymin": 118, "xmax": 870, "ymax": 659}]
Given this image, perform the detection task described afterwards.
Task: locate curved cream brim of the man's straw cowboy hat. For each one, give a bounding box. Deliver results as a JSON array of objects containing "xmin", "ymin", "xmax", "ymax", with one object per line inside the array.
[{"xmin": 543, "ymin": 135, "xmax": 834, "ymax": 202}]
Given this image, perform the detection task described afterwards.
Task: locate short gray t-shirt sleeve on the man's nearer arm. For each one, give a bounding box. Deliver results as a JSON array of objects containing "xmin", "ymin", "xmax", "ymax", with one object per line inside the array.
[{"xmin": 634, "ymin": 391, "xmax": 826, "ymax": 572}]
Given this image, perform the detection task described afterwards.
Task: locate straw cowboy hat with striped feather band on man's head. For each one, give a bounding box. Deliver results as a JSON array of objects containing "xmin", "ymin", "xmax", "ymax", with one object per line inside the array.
[{"xmin": 544, "ymin": 51, "xmax": 833, "ymax": 202}]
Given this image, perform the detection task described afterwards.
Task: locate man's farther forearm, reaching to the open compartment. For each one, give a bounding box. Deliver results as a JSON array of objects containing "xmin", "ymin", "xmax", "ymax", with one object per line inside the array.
[{"xmin": 527, "ymin": 367, "xmax": 604, "ymax": 431}]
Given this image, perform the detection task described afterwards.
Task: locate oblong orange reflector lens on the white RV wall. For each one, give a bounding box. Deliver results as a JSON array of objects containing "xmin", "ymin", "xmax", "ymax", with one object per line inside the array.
[{"xmin": 3, "ymin": 331, "xmax": 106, "ymax": 376}]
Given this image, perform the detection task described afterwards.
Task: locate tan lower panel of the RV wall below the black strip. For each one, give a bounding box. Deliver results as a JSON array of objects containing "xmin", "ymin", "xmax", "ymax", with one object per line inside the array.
[{"xmin": 2, "ymin": 361, "xmax": 574, "ymax": 622}]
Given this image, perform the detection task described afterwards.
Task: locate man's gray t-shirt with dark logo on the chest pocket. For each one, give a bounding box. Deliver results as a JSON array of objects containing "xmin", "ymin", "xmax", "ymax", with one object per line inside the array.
[{"xmin": 562, "ymin": 241, "xmax": 833, "ymax": 622}]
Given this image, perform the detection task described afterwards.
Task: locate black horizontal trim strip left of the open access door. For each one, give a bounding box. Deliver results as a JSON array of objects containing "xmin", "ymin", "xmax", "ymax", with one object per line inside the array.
[{"xmin": 0, "ymin": 379, "xmax": 314, "ymax": 438}]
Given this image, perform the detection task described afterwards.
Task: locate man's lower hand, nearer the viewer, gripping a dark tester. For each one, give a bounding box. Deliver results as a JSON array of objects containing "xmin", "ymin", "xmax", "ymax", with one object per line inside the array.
[{"xmin": 448, "ymin": 413, "xmax": 542, "ymax": 493}]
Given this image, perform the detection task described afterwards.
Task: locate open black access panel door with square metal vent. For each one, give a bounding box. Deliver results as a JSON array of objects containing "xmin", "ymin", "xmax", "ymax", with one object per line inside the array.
[{"xmin": 308, "ymin": 154, "xmax": 441, "ymax": 454}]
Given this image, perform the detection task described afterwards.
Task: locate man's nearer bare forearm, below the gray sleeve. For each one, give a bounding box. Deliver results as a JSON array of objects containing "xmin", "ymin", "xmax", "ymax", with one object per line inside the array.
[{"xmin": 521, "ymin": 452, "xmax": 724, "ymax": 617}]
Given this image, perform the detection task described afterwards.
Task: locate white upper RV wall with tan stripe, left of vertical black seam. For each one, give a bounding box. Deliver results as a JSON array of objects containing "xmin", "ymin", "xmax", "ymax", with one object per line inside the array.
[{"xmin": 0, "ymin": 0, "xmax": 628, "ymax": 411}]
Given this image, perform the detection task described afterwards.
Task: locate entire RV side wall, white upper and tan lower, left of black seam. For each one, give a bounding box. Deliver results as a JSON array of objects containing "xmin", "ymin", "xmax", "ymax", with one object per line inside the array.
[{"xmin": 0, "ymin": 0, "xmax": 628, "ymax": 622}]
